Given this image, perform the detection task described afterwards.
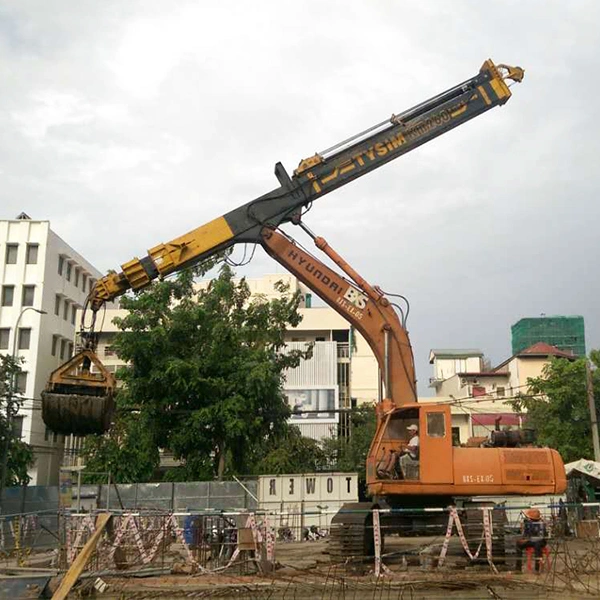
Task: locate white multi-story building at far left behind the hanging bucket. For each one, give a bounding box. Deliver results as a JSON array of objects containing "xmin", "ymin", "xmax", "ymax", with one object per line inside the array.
[{"xmin": 0, "ymin": 214, "xmax": 101, "ymax": 485}]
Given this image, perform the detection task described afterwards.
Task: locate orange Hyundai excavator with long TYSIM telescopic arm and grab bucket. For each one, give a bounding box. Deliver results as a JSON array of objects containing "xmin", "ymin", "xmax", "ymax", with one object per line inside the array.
[{"xmin": 42, "ymin": 60, "xmax": 566, "ymax": 558}]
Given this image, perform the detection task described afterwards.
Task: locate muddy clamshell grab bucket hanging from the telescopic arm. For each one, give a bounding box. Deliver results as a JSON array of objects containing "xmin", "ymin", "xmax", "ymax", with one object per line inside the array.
[{"xmin": 42, "ymin": 350, "xmax": 116, "ymax": 435}]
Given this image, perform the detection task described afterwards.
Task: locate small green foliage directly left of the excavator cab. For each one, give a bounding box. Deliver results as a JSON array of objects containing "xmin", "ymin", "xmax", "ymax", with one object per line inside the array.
[{"xmin": 324, "ymin": 405, "xmax": 376, "ymax": 481}]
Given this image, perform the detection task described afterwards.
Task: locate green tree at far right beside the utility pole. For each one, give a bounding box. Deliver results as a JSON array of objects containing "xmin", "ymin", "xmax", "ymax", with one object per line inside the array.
[{"xmin": 513, "ymin": 350, "xmax": 600, "ymax": 462}]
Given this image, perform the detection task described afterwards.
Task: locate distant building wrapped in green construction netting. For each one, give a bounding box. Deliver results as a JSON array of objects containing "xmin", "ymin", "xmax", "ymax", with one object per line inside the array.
[{"xmin": 510, "ymin": 315, "xmax": 585, "ymax": 356}]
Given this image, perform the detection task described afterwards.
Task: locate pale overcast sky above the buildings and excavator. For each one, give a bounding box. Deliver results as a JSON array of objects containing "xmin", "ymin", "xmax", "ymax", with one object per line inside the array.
[{"xmin": 0, "ymin": 0, "xmax": 600, "ymax": 395}]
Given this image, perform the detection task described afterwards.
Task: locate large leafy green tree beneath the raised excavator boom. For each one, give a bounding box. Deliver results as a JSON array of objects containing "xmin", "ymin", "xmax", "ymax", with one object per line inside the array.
[{"xmin": 86, "ymin": 265, "xmax": 308, "ymax": 480}]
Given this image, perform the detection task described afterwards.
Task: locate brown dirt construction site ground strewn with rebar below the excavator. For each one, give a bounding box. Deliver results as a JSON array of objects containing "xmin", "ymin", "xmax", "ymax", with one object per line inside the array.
[{"xmin": 17, "ymin": 537, "xmax": 600, "ymax": 600}]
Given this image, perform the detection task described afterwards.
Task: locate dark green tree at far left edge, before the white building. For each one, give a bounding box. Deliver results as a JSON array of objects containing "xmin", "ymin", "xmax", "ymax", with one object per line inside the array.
[{"xmin": 0, "ymin": 355, "xmax": 34, "ymax": 486}]
